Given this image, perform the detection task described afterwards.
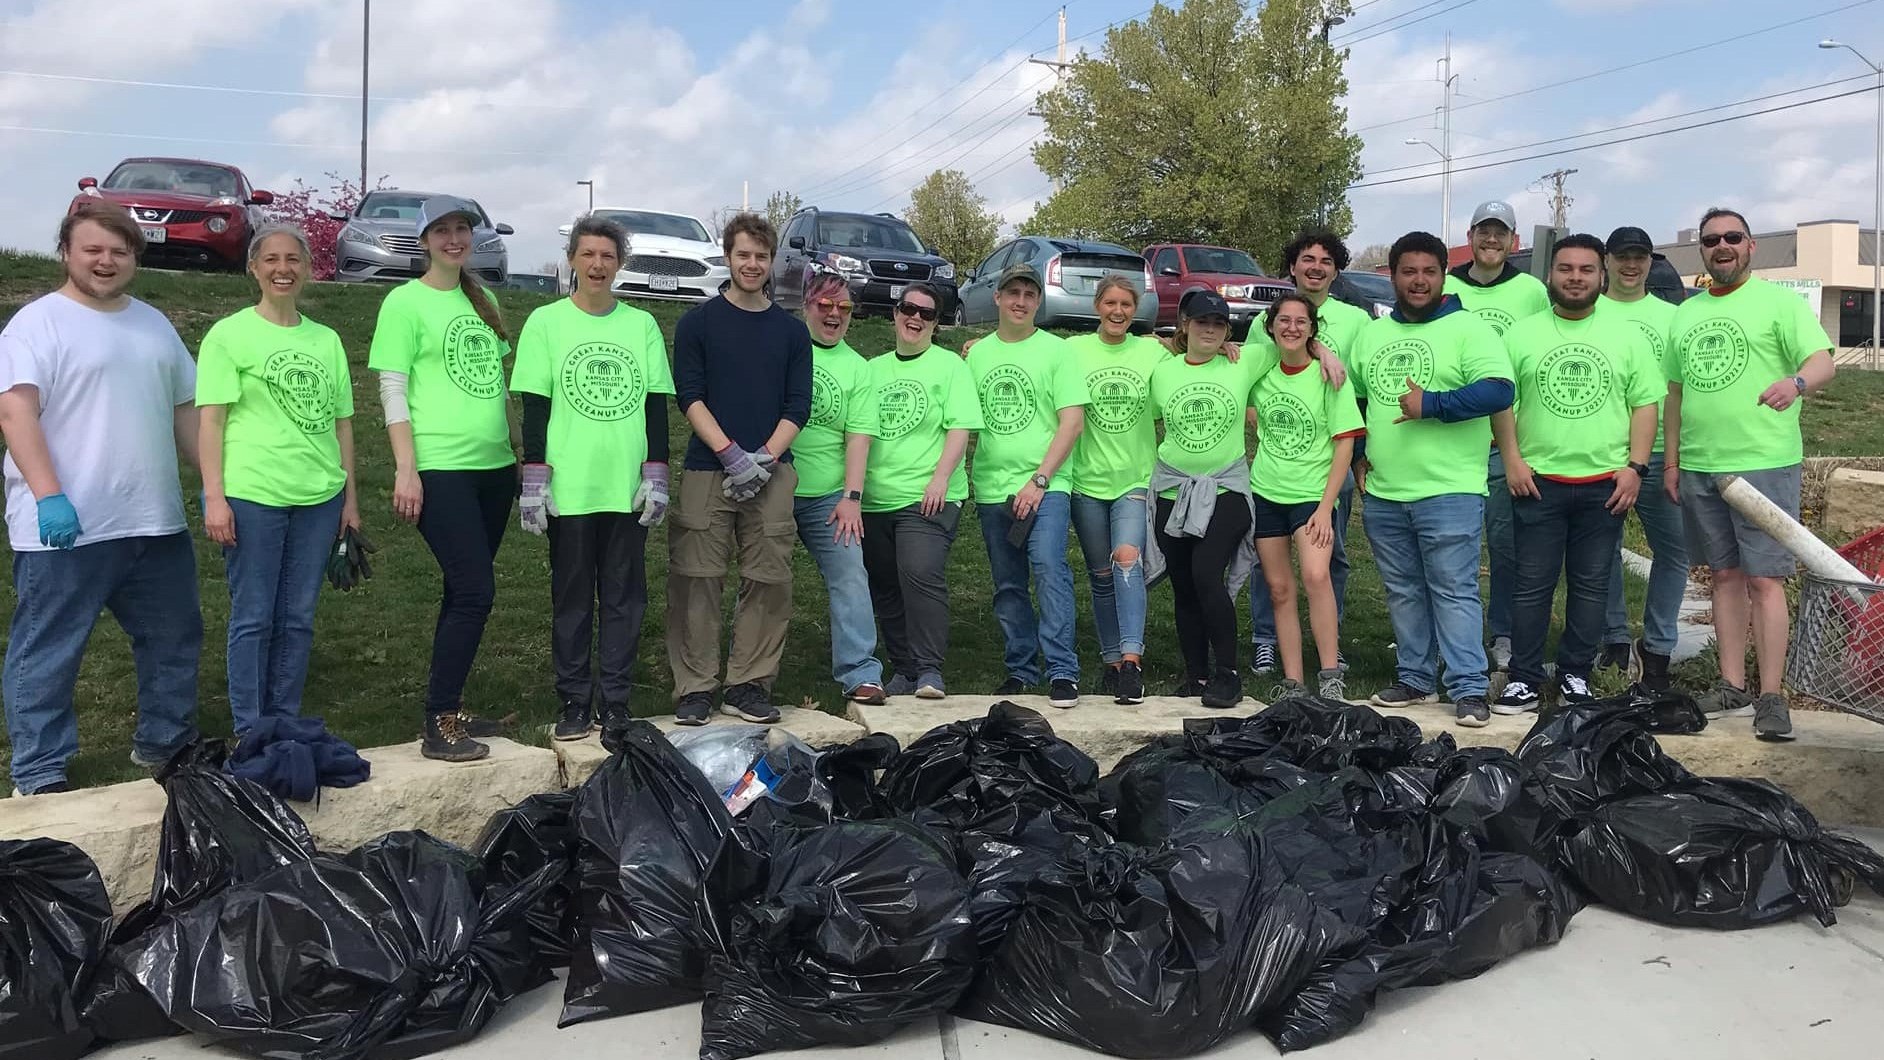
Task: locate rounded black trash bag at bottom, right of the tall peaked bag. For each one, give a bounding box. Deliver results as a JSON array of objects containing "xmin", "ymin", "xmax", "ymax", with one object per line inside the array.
[{"xmin": 699, "ymin": 821, "xmax": 978, "ymax": 1060}]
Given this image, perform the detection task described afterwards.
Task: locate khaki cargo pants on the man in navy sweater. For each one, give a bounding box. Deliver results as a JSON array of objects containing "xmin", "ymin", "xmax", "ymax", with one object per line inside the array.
[{"xmin": 667, "ymin": 463, "xmax": 799, "ymax": 699}]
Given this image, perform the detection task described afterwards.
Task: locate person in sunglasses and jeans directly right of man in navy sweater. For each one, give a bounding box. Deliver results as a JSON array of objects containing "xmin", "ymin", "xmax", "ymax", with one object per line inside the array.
[{"xmin": 791, "ymin": 269, "xmax": 884, "ymax": 704}]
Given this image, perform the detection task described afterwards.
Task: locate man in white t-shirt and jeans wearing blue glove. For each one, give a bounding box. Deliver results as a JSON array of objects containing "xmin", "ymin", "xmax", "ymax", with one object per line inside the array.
[{"xmin": 0, "ymin": 201, "xmax": 203, "ymax": 795}]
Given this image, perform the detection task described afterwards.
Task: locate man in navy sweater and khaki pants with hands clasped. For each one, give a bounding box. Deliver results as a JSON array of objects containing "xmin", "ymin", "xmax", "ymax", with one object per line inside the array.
[{"xmin": 667, "ymin": 213, "xmax": 812, "ymax": 725}]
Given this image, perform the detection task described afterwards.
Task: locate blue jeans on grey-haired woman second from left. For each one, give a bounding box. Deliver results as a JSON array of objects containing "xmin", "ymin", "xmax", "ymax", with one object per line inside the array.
[{"xmin": 222, "ymin": 493, "xmax": 343, "ymax": 736}]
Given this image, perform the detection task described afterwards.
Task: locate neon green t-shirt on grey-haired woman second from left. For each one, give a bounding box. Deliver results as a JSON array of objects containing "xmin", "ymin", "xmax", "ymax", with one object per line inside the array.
[{"xmin": 196, "ymin": 309, "xmax": 352, "ymax": 508}]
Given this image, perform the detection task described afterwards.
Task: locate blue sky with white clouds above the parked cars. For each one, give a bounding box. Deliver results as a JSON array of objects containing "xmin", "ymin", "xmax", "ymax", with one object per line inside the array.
[{"xmin": 0, "ymin": 0, "xmax": 1884, "ymax": 269}]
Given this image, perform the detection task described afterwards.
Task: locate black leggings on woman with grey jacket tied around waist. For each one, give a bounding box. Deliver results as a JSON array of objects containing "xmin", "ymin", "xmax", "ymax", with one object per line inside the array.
[{"xmin": 1153, "ymin": 493, "xmax": 1249, "ymax": 680}]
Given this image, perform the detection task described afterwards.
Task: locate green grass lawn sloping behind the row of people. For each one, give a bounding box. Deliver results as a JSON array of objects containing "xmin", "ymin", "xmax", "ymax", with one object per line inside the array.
[{"xmin": 0, "ymin": 252, "xmax": 1884, "ymax": 791}]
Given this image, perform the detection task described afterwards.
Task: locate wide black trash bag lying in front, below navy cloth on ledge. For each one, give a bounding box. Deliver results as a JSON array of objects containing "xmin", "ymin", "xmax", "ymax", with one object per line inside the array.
[{"xmin": 113, "ymin": 832, "xmax": 556, "ymax": 1060}]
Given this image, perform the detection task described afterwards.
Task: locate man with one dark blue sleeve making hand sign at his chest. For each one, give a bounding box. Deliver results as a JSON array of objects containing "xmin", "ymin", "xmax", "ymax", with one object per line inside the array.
[{"xmin": 1355, "ymin": 232, "xmax": 1511, "ymax": 727}]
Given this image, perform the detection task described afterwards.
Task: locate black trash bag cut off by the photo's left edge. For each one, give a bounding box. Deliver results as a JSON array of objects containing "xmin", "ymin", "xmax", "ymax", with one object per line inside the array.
[{"xmin": 0, "ymin": 840, "xmax": 111, "ymax": 1060}]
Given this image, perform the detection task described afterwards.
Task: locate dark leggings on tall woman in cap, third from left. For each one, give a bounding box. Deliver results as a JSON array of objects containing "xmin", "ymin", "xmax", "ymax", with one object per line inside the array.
[{"xmin": 418, "ymin": 467, "xmax": 516, "ymax": 714}]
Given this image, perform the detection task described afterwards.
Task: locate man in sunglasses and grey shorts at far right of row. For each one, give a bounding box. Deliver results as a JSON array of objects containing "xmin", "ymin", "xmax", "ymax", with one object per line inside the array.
[{"xmin": 1662, "ymin": 207, "xmax": 1833, "ymax": 740}]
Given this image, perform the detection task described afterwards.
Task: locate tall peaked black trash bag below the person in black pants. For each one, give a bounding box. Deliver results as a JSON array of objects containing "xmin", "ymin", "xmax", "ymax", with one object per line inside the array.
[{"xmin": 558, "ymin": 721, "xmax": 750, "ymax": 1026}]
